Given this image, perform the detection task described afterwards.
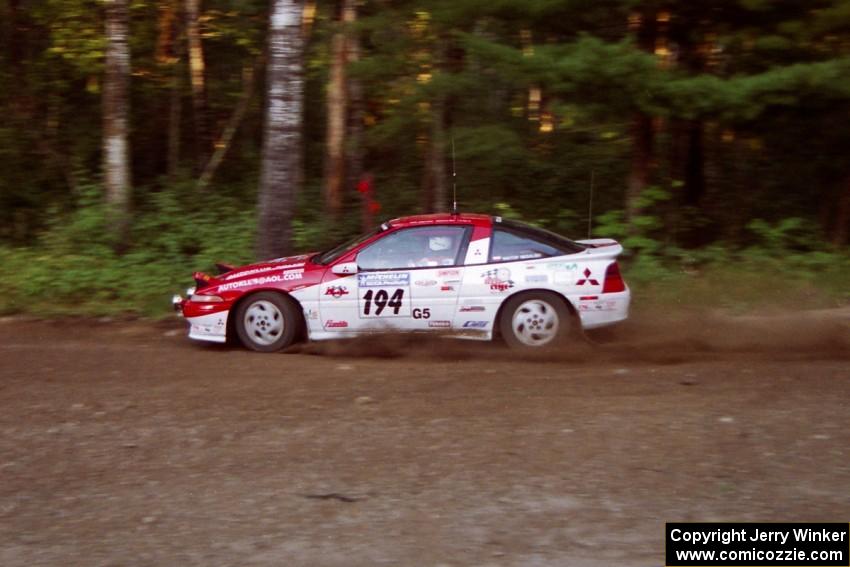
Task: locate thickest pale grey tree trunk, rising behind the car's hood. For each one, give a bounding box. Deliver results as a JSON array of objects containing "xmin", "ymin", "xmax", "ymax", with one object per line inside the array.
[{"xmin": 257, "ymin": 0, "xmax": 304, "ymax": 258}]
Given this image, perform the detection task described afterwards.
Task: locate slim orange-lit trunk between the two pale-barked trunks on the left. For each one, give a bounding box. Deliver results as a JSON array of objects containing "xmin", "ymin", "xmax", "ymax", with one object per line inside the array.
[{"xmin": 185, "ymin": 0, "xmax": 210, "ymax": 172}]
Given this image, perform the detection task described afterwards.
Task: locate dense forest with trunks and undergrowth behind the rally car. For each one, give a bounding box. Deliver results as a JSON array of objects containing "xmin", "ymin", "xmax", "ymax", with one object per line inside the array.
[{"xmin": 0, "ymin": 0, "xmax": 850, "ymax": 316}]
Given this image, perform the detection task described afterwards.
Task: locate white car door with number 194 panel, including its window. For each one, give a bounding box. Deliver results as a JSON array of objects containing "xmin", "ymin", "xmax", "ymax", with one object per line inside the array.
[{"xmin": 321, "ymin": 225, "xmax": 471, "ymax": 332}]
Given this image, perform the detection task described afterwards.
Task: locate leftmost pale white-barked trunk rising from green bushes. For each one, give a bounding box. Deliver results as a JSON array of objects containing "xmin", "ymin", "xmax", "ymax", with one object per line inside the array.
[{"xmin": 103, "ymin": 0, "xmax": 131, "ymax": 241}]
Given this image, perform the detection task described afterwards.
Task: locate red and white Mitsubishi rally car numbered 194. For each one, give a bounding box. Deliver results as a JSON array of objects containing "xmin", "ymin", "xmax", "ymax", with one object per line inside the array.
[{"xmin": 174, "ymin": 213, "xmax": 630, "ymax": 352}]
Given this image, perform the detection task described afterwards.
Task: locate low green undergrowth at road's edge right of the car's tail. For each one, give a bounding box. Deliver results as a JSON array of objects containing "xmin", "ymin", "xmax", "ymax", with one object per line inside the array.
[{"xmin": 626, "ymin": 218, "xmax": 850, "ymax": 310}]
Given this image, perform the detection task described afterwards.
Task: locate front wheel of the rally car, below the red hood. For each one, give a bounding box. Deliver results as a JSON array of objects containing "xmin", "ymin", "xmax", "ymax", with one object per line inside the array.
[{"xmin": 233, "ymin": 291, "xmax": 302, "ymax": 352}]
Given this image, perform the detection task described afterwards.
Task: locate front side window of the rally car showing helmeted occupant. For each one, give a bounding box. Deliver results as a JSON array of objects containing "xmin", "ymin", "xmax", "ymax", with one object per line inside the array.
[{"xmin": 357, "ymin": 225, "xmax": 469, "ymax": 270}]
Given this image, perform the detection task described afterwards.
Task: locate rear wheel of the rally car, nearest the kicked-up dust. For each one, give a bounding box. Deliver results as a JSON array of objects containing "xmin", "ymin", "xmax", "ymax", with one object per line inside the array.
[{"xmin": 499, "ymin": 291, "xmax": 576, "ymax": 349}]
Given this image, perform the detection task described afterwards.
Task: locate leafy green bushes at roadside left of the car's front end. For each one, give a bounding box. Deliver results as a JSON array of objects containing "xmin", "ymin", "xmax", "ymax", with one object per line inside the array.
[{"xmin": 0, "ymin": 187, "xmax": 255, "ymax": 316}]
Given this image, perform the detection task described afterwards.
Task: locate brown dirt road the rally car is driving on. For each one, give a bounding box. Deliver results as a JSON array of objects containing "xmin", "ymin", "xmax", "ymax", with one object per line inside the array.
[{"xmin": 0, "ymin": 317, "xmax": 850, "ymax": 567}]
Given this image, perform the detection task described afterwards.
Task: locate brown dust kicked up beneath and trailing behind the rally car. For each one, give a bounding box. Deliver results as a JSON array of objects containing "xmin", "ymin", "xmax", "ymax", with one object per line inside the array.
[{"xmin": 286, "ymin": 310, "xmax": 850, "ymax": 364}]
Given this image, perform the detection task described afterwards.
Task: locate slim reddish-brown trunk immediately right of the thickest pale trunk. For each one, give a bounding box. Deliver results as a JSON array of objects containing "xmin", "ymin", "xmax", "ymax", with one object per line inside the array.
[{"xmin": 324, "ymin": 6, "xmax": 344, "ymax": 221}]
